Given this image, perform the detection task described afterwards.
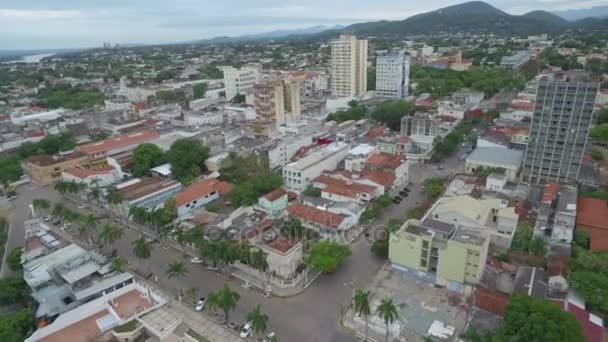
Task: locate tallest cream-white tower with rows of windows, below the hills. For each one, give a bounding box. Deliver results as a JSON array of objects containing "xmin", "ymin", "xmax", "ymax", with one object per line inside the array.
[{"xmin": 331, "ymin": 35, "xmax": 367, "ymax": 97}]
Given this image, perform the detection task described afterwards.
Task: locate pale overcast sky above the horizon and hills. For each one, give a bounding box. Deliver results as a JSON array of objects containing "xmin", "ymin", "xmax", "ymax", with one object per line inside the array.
[{"xmin": 0, "ymin": 0, "xmax": 608, "ymax": 50}]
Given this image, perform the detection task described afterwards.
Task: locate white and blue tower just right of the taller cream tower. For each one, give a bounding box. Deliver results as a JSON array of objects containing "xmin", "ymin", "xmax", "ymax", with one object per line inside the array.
[{"xmin": 376, "ymin": 51, "xmax": 410, "ymax": 99}]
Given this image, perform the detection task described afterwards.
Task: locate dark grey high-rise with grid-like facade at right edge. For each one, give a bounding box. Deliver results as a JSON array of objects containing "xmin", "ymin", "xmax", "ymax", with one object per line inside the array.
[{"xmin": 522, "ymin": 74, "xmax": 599, "ymax": 184}]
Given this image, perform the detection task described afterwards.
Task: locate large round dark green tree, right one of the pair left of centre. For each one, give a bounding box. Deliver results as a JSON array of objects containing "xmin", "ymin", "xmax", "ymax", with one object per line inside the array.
[{"xmin": 167, "ymin": 138, "xmax": 209, "ymax": 184}]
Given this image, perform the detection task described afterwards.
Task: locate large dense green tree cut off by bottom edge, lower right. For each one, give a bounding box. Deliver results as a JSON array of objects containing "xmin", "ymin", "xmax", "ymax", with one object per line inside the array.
[{"xmin": 495, "ymin": 294, "xmax": 585, "ymax": 342}]
